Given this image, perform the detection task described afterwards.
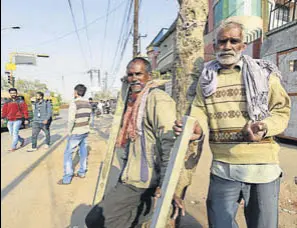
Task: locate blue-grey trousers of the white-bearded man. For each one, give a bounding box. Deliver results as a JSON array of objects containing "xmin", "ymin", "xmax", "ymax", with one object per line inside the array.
[{"xmin": 207, "ymin": 174, "xmax": 280, "ymax": 228}]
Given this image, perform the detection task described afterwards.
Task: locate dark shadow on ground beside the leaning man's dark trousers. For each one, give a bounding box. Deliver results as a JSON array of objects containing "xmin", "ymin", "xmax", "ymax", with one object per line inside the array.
[{"xmin": 66, "ymin": 204, "xmax": 92, "ymax": 228}]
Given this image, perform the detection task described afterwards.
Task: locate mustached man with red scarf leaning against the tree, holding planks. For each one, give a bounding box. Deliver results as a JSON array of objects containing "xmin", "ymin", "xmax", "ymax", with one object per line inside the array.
[{"xmin": 86, "ymin": 57, "xmax": 180, "ymax": 228}]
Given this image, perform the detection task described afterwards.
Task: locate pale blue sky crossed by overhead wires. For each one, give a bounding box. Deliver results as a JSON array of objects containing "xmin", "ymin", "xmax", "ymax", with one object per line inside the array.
[{"xmin": 1, "ymin": 0, "xmax": 179, "ymax": 100}]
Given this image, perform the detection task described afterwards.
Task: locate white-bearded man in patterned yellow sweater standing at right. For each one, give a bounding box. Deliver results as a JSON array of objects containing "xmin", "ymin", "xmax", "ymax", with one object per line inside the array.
[{"xmin": 174, "ymin": 22, "xmax": 290, "ymax": 228}]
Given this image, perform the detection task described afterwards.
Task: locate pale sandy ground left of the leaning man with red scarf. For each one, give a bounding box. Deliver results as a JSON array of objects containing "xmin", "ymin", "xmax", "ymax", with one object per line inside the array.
[{"xmin": 1, "ymin": 115, "xmax": 110, "ymax": 228}]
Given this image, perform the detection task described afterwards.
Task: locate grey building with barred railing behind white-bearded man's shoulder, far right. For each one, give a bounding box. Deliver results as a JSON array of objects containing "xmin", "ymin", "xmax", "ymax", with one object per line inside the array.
[{"xmin": 261, "ymin": 0, "xmax": 297, "ymax": 140}]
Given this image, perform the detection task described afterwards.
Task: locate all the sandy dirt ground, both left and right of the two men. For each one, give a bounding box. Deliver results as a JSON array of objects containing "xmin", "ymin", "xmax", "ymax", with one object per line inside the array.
[{"xmin": 1, "ymin": 114, "xmax": 297, "ymax": 228}]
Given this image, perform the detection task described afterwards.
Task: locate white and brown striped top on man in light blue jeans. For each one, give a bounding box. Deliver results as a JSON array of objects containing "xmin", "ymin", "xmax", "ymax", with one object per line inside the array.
[{"xmin": 68, "ymin": 97, "xmax": 92, "ymax": 135}]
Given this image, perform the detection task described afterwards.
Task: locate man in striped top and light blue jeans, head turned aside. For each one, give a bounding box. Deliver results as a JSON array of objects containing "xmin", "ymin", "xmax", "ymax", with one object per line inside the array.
[{"xmin": 58, "ymin": 84, "xmax": 92, "ymax": 184}]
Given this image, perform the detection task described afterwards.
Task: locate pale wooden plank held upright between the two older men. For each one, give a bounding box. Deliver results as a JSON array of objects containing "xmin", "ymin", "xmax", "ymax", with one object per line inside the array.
[{"xmin": 151, "ymin": 116, "xmax": 196, "ymax": 228}]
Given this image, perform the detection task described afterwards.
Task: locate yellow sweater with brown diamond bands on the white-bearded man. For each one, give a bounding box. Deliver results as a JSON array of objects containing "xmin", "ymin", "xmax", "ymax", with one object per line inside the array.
[{"xmin": 191, "ymin": 68, "xmax": 290, "ymax": 164}]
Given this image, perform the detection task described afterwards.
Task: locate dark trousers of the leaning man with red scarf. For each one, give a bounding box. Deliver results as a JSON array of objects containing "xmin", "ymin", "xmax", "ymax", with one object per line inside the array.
[{"xmin": 86, "ymin": 182, "xmax": 155, "ymax": 228}]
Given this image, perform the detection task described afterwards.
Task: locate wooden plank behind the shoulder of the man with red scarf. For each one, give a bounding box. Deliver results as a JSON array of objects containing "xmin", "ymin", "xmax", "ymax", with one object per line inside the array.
[{"xmin": 93, "ymin": 83, "xmax": 129, "ymax": 204}]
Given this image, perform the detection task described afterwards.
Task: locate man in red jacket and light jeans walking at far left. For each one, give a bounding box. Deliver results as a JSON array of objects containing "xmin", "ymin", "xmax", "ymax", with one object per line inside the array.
[{"xmin": 1, "ymin": 88, "xmax": 29, "ymax": 151}]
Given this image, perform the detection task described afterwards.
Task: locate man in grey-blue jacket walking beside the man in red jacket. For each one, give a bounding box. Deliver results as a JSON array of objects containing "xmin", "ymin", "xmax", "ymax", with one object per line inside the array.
[{"xmin": 27, "ymin": 92, "xmax": 52, "ymax": 152}]
